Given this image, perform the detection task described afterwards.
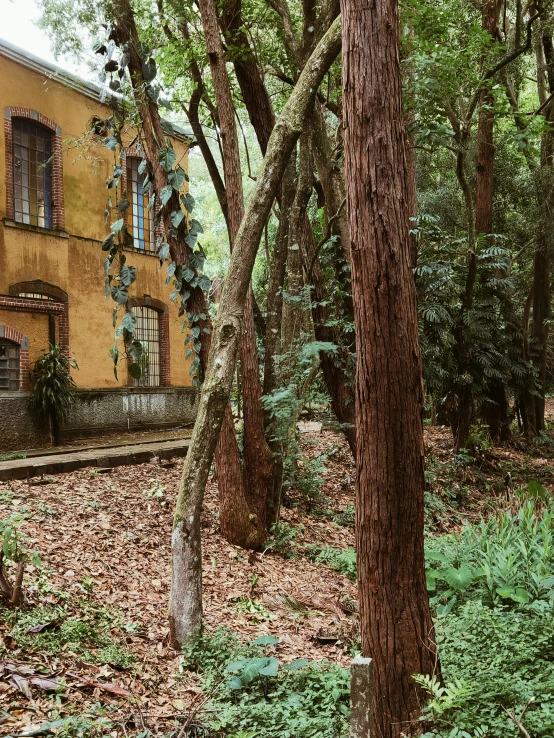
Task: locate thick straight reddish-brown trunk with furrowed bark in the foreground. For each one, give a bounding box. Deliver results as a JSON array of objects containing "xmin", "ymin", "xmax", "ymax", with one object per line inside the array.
[{"xmin": 341, "ymin": 0, "xmax": 437, "ymax": 738}]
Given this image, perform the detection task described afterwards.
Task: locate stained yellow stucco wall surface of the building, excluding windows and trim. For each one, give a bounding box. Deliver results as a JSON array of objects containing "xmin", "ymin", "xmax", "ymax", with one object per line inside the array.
[{"xmin": 0, "ymin": 50, "xmax": 191, "ymax": 388}]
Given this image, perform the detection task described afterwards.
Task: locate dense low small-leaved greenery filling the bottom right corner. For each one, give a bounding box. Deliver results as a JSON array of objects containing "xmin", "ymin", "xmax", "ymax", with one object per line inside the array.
[{"xmin": 417, "ymin": 602, "xmax": 554, "ymax": 738}]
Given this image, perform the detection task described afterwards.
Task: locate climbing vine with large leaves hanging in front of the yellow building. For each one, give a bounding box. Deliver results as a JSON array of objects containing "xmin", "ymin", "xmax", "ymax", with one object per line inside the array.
[{"xmin": 93, "ymin": 20, "xmax": 211, "ymax": 384}]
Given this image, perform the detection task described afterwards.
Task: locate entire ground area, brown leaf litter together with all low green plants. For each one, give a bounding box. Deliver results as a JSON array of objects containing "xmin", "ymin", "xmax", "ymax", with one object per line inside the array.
[{"xmin": 0, "ymin": 416, "xmax": 554, "ymax": 738}]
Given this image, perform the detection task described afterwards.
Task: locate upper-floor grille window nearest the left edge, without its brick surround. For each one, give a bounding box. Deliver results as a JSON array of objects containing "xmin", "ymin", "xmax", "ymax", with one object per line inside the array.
[{"xmin": 12, "ymin": 118, "xmax": 53, "ymax": 228}]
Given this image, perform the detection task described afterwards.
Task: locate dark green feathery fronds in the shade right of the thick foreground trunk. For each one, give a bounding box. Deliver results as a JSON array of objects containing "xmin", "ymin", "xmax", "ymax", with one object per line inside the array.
[{"xmin": 413, "ymin": 214, "xmax": 536, "ymax": 442}]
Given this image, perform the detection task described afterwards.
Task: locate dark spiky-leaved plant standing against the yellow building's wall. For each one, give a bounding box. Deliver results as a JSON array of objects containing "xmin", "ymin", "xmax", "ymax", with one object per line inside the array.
[{"xmin": 29, "ymin": 343, "xmax": 79, "ymax": 446}]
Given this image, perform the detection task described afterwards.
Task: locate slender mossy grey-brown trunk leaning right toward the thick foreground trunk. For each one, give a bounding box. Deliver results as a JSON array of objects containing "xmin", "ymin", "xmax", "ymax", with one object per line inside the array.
[{"xmin": 169, "ymin": 19, "xmax": 341, "ymax": 645}]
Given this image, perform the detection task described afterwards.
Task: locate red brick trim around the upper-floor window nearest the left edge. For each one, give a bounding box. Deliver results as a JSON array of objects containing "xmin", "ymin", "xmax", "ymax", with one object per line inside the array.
[{"xmin": 4, "ymin": 106, "xmax": 65, "ymax": 231}]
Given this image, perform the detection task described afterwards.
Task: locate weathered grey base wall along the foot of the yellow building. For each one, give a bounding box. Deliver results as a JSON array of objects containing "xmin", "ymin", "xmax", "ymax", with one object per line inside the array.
[{"xmin": 0, "ymin": 387, "xmax": 198, "ymax": 453}]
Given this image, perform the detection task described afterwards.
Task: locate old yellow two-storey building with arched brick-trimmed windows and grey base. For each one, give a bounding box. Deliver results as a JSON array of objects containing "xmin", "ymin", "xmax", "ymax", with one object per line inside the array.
[{"xmin": 0, "ymin": 41, "xmax": 195, "ymax": 451}]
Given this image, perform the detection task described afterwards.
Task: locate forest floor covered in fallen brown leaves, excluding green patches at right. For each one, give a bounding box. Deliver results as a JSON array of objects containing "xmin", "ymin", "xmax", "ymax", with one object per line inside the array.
[{"xmin": 0, "ymin": 403, "xmax": 554, "ymax": 737}]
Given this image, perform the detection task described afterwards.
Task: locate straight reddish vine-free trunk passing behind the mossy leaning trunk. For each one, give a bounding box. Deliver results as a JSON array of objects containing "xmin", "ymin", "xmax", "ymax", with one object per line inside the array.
[{"xmin": 199, "ymin": 0, "xmax": 273, "ymax": 546}]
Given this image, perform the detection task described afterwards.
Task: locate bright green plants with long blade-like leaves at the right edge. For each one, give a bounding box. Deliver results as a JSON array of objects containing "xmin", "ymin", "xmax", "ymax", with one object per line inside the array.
[{"xmin": 426, "ymin": 502, "xmax": 554, "ymax": 615}]
